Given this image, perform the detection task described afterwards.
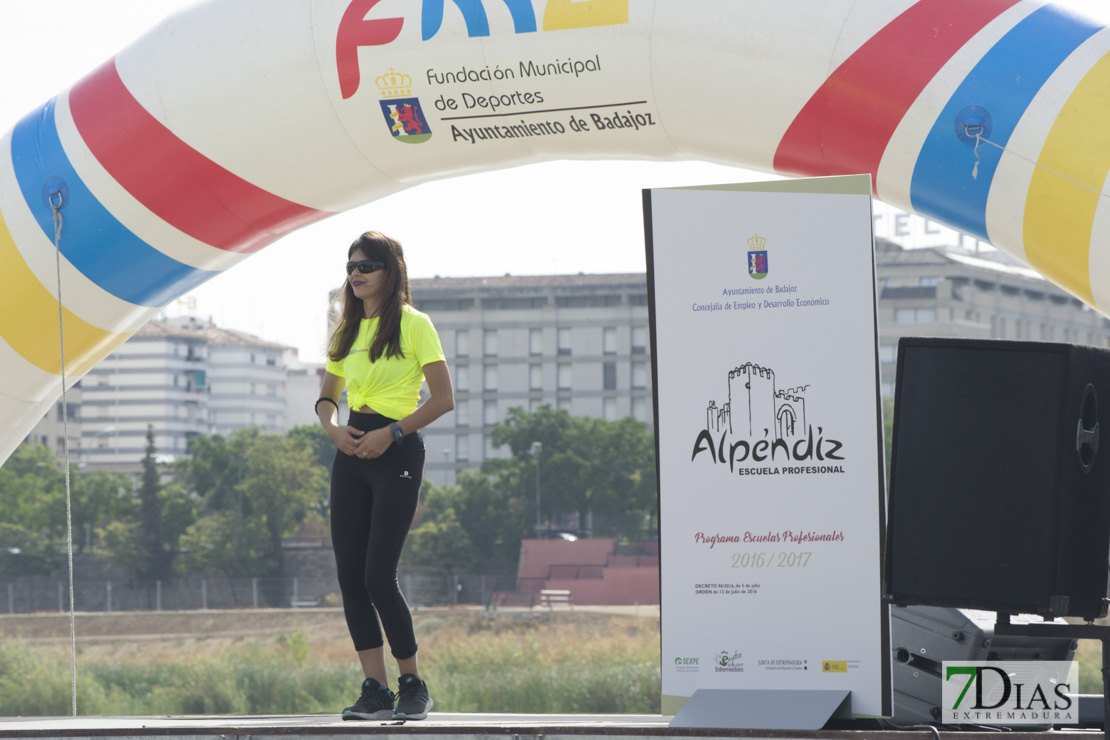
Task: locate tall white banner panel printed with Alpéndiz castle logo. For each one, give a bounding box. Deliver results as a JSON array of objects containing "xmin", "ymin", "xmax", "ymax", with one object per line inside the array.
[{"xmin": 644, "ymin": 175, "xmax": 891, "ymax": 722}]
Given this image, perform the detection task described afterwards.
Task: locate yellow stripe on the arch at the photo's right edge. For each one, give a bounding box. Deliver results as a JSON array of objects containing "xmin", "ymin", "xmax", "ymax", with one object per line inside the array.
[{"xmin": 1022, "ymin": 54, "xmax": 1110, "ymax": 305}]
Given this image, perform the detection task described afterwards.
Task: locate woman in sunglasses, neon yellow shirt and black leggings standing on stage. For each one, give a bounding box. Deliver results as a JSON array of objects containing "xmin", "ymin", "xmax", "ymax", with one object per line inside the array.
[{"xmin": 316, "ymin": 232, "xmax": 455, "ymax": 719}]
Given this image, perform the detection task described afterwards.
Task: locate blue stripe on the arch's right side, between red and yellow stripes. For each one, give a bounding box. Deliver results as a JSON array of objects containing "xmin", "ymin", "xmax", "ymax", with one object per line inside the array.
[{"xmin": 910, "ymin": 6, "xmax": 1102, "ymax": 240}]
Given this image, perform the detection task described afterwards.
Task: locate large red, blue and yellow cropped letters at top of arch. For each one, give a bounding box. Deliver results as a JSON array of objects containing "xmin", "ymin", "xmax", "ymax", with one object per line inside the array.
[{"xmin": 335, "ymin": 0, "xmax": 628, "ymax": 100}]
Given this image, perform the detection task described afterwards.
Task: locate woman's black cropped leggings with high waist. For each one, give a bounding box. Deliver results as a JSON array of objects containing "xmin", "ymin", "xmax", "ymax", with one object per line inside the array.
[{"xmin": 332, "ymin": 412, "xmax": 424, "ymax": 659}]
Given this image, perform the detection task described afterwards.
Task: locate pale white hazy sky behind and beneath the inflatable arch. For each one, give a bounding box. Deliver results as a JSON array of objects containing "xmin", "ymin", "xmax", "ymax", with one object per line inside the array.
[{"xmin": 0, "ymin": 0, "xmax": 1110, "ymax": 361}]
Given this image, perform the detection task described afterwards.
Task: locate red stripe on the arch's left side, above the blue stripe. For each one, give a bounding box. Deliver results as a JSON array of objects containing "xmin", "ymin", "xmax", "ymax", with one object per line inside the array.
[{"xmin": 70, "ymin": 60, "xmax": 332, "ymax": 252}]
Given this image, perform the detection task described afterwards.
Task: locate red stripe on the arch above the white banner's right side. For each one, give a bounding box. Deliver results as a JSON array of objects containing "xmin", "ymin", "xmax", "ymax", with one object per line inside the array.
[{"xmin": 775, "ymin": 0, "xmax": 1019, "ymax": 192}]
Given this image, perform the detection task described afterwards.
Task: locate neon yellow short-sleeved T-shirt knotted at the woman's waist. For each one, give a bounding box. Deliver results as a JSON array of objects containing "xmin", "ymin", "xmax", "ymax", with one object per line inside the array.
[{"xmin": 325, "ymin": 305, "xmax": 446, "ymax": 419}]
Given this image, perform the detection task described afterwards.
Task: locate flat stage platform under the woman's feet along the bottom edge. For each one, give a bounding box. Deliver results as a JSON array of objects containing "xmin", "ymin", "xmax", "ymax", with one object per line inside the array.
[{"xmin": 0, "ymin": 712, "xmax": 1103, "ymax": 740}]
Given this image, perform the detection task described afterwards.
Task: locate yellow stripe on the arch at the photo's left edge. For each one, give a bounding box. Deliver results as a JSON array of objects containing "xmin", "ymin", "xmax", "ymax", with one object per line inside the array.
[{"xmin": 0, "ymin": 205, "xmax": 130, "ymax": 376}]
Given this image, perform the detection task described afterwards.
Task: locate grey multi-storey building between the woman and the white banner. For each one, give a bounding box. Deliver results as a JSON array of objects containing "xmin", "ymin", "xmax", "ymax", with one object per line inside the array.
[{"xmin": 412, "ymin": 273, "xmax": 653, "ymax": 484}]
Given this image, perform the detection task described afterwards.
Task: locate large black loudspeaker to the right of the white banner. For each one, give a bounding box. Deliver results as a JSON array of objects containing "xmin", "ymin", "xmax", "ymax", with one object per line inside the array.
[{"xmin": 884, "ymin": 337, "xmax": 1110, "ymax": 619}]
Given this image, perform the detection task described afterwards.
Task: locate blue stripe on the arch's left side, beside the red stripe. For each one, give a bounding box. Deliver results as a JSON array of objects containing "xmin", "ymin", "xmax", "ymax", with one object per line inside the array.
[{"xmin": 11, "ymin": 100, "xmax": 220, "ymax": 306}]
